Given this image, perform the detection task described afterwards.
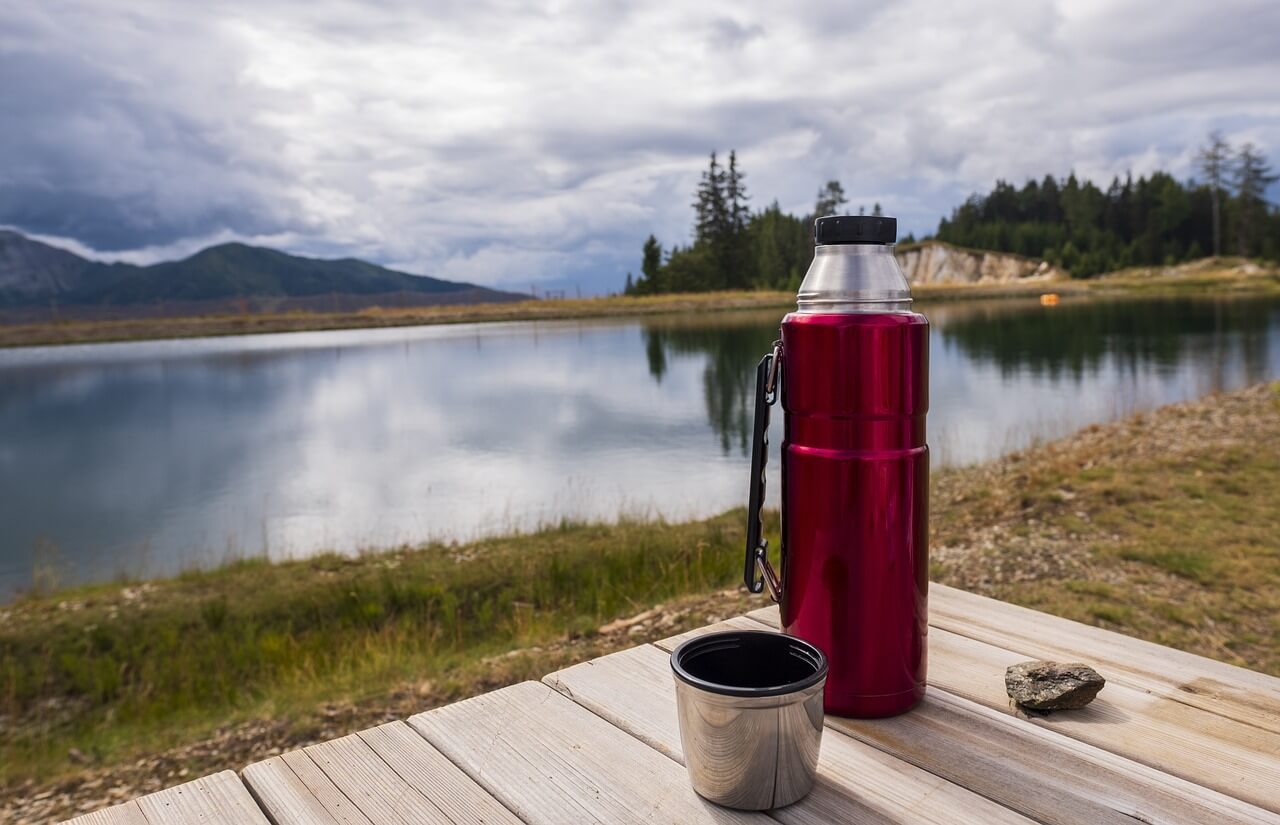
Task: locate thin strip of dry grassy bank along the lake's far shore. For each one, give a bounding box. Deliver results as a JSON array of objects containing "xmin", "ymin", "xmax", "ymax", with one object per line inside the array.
[{"xmin": 0, "ymin": 258, "xmax": 1280, "ymax": 347}]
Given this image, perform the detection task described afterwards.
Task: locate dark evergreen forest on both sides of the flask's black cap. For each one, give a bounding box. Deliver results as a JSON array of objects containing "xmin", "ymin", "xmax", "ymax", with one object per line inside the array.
[{"xmin": 626, "ymin": 133, "xmax": 1280, "ymax": 295}]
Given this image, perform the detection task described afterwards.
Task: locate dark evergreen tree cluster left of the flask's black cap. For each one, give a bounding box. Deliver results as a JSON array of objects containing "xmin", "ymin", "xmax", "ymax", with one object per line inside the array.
[{"xmin": 625, "ymin": 151, "xmax": 911, "ymax": 295}]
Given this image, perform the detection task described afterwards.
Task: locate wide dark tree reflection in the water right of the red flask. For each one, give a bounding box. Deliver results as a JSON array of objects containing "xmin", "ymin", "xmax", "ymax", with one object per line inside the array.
[{"xmin": 937, "ymin": 298, "xmax": 1280, "ymax": 386}]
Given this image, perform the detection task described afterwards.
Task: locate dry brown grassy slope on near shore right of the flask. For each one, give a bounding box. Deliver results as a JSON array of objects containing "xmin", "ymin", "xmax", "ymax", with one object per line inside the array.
[{"xmin": 932, "ymin": 382, "xmax": 1280, "ymax": 675}]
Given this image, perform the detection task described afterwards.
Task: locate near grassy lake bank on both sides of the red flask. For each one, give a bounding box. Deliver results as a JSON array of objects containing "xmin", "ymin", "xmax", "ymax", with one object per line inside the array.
[{"xmin": 0, "ymin": 384, "xmax": 1280, "ymax": 820}]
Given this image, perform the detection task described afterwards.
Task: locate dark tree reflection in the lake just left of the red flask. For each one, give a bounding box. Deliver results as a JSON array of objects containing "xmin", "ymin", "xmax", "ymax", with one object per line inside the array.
[{"xmin": 643, "ymin": 313, "xmax": 780, "ymax": 455}]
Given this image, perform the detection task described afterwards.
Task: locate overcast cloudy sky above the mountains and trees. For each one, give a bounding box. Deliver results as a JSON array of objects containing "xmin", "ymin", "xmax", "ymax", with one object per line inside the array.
[{"xmin": 0, "ymin": 0, "xmax": 1280, "ymax": 293}]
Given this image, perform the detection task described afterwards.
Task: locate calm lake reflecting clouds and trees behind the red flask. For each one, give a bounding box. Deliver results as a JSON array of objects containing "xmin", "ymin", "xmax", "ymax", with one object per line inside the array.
[{"xmin": 0, "ymin": 292, "xmax": 1280, "ymax": 599}]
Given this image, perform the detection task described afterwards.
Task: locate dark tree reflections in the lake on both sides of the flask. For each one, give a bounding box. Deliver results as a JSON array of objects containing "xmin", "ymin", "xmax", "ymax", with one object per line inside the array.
[{"xmin": 643, "ymin": 298, "xmax": 1280, "ymax": 455}]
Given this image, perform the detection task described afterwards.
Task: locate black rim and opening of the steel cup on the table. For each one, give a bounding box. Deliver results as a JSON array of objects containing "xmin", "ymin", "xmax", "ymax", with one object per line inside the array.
[{"xmin": 671, "ymin": 631, "xmax": 827, "ymax": 697}]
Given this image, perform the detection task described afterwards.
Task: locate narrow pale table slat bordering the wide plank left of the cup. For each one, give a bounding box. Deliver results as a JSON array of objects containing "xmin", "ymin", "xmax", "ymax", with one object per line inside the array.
[{"xmin": 358, "ymin": 721, "xmax": 520, "ymax": 825}]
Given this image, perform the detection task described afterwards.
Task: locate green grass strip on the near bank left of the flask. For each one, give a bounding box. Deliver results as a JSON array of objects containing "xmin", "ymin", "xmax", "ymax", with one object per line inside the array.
[{"xmin": 0, "ymin": 510, "xmax": 762, "ymax": 782}]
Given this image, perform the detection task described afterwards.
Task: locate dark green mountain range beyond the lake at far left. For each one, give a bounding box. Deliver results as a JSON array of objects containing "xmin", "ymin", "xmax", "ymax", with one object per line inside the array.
[{"xmin": 0, "ymin": 230, "xmax": 527, "ymax": 318}]
